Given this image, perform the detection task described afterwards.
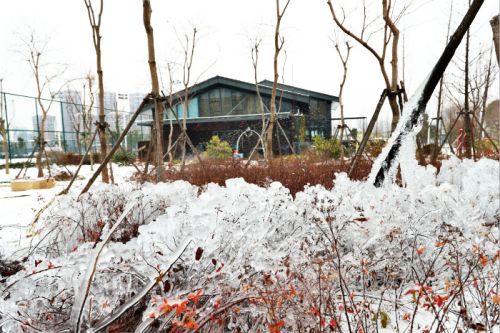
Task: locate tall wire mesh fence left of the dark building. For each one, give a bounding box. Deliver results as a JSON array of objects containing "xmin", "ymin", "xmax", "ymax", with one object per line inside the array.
[{"xmin": 0, "ymin": 92, "xmax": 151, "ymax": 161}]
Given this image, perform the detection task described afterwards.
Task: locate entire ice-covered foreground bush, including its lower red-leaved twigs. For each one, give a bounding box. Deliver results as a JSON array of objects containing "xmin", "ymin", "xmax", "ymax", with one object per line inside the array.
[{"xmin": 0, "ymin": 160, "xmax": 500, "ymax": 332}]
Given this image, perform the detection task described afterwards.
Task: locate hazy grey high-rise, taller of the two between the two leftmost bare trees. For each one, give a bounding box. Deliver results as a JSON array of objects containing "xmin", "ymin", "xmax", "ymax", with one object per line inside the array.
[{"xmin": 59, "ymin": 89, "xmax": 85, "ymax": 151}]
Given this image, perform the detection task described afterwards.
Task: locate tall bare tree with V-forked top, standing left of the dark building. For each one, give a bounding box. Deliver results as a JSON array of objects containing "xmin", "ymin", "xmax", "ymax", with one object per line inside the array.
[{"xmin": 83, "ymin": 0, "xmax": 109, "ymax": 183}]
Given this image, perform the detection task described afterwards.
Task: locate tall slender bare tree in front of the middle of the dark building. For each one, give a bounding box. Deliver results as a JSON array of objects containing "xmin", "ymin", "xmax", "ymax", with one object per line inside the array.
[{"xmin": 265, "ymin": 0, "xmax": 290, "ymax": 159}]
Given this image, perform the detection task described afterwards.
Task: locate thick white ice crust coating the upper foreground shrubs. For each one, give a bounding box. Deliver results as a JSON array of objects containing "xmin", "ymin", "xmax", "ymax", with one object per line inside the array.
[{"xmin": 0, "ymin": 159, "xmax": 500, "ymax": 332}]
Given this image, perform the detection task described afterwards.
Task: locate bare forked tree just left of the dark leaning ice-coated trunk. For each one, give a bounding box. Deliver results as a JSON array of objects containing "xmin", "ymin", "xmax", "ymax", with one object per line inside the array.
[{"xmin": 327, "ymin": 0, "xmax": 408, "ymax": 131}]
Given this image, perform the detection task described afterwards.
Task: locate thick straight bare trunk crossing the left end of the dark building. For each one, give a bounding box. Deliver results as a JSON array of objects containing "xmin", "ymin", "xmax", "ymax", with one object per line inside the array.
[{"xmin": 142, "ymin": 0, "xmax": 163, "ymax": 181}]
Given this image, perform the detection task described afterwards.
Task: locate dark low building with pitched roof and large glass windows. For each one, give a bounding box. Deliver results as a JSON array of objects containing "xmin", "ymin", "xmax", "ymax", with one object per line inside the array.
[{"xmin": 139, "ymin": 76, "xmax": 338, "ymax": 155}]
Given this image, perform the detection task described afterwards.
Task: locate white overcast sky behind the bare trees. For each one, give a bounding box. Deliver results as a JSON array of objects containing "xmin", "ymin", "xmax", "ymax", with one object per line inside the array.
[{"xmin": 0, "ymin": 0, "xmax": 499, "ymax": 132}]
